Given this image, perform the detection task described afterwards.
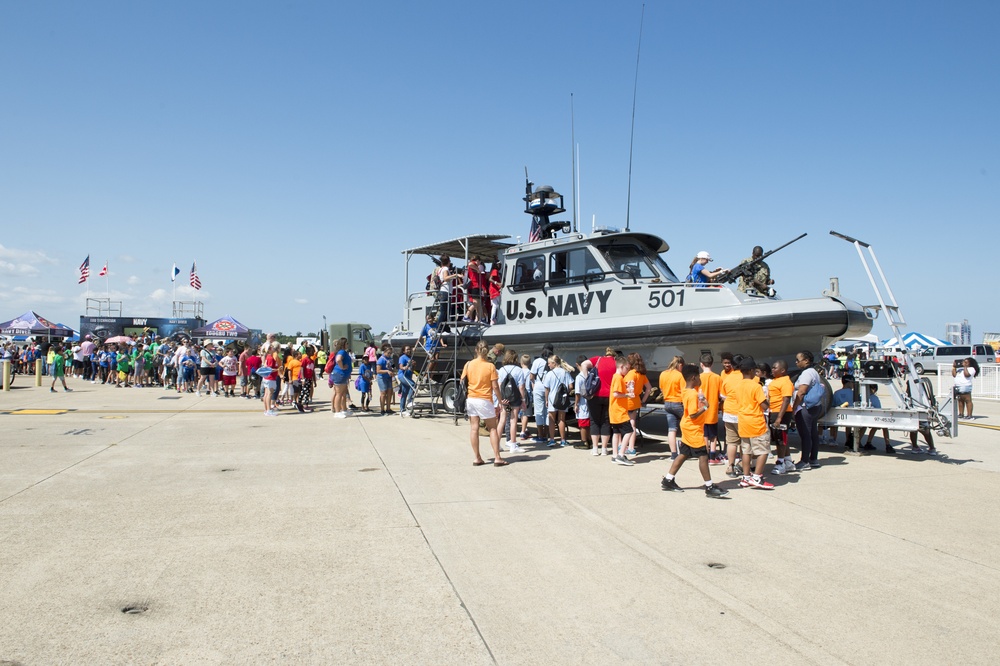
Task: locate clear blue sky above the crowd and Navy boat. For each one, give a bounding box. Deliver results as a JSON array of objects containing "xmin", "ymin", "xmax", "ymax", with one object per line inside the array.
[{"xmin": 0, "ymin": 1, "xmax": 1000, "ymax": 338}]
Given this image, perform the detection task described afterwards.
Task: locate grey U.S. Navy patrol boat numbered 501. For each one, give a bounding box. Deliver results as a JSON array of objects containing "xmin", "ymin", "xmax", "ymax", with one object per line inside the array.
[{"xmin": 387, "ymin": 176, "xmax": 873, "ymax": 396}]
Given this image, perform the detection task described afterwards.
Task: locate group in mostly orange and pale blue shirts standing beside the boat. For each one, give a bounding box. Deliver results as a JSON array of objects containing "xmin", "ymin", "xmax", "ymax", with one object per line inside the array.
[{"xmin": 450, "ymin": 342, "xmax": 848, "ymax": 497}]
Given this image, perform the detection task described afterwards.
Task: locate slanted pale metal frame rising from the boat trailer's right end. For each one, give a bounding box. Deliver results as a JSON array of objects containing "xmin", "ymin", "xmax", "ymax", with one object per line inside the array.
[{"xmin": 830, "ymin": 231, "xmax": 958, "ymax": 437}]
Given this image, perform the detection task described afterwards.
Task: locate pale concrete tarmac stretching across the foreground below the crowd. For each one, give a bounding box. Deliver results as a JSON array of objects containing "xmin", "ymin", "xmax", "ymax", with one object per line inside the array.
[{"xmin": 0, "ymin": 378, "xmax": 1000, "ymax": 665}]
